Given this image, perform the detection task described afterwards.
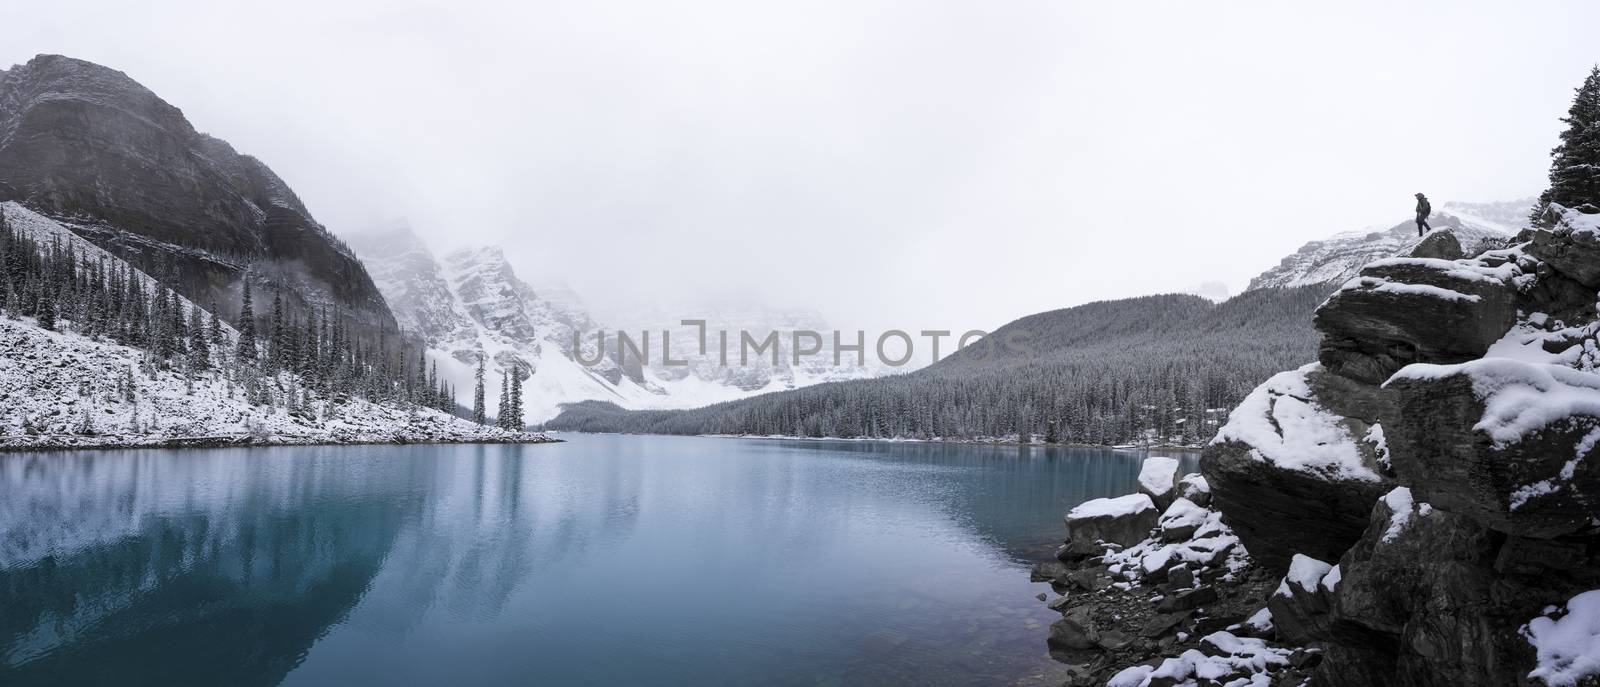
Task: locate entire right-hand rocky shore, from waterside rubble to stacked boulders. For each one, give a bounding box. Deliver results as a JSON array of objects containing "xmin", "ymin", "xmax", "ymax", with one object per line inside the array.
[{"xmin": 1037, "ymin": 207, "xmax": 1600, "ymax": 687}]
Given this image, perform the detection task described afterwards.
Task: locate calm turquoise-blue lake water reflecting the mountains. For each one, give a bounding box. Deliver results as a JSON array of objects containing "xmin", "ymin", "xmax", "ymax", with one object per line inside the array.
[{"xmin": 0, "ymin": 436, "xmax": 1192, "ymax": 687}]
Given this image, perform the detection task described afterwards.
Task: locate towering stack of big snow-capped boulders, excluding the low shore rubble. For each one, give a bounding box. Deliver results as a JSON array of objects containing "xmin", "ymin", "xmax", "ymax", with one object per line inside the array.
[{"xmin": 1202, "ymin": 201, "xmax": 1600, "ymax": 678}]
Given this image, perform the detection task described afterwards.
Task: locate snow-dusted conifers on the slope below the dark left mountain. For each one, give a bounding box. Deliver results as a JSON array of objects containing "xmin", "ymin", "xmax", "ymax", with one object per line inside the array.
[{"xmin": 0, "ymin": 213, "xmax": 464, "ymax": 415}]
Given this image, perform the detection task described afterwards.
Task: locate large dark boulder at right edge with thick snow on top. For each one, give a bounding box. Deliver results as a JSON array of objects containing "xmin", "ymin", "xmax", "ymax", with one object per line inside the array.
[{"xmin": 1382, "ymin": 359, "xmax": 1600, "ymax": 538}]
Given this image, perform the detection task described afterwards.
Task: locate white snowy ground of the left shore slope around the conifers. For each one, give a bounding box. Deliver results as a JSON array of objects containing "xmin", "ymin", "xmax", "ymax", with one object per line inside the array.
[{"xmin": 0, "ymin": 202, "xmax": 538, "ymax": 448}]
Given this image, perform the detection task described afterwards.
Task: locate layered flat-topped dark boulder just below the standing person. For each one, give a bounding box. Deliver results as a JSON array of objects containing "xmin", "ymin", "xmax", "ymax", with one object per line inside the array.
[{"xmin": 1314, "ymin": 258, "xmax": 1522, "ymax": 384}]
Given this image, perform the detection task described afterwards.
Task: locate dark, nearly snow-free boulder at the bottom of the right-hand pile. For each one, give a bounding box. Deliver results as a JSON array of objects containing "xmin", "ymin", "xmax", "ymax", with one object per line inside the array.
[{"xmin": 1318, "ymin": 487, "xmax": 1582, "ymax": 687}]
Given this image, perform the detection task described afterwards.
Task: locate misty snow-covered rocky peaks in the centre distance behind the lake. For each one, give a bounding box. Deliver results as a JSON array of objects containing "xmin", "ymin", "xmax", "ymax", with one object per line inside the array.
[{"xmin": 352, "ymin": 224, "xmax": 877, "ymax": 424}]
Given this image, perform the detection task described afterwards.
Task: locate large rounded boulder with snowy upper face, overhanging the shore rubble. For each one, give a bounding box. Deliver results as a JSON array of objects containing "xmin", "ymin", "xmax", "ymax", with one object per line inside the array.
[{"xmin": 1200, "ymin": 365, "xmax": 1394, "ymax": 570}]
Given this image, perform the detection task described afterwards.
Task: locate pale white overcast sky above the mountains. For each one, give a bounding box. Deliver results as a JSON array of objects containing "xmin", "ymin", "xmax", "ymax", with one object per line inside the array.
[{"xmin": 0, "ymin": 0, "xmax": 1600, "ymax": 330}]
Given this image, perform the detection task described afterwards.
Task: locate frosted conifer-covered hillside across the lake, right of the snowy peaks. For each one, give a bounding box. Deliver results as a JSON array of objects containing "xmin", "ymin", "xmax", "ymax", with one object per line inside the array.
[{"xmin": 546, "ymin": 285, "xmax": 1333, "ymax": 445}]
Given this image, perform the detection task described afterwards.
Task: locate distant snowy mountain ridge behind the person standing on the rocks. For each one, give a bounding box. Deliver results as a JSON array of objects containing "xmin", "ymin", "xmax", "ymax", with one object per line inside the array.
[{"xmin": 1246, "ymin": 200, "xmax": 1531, "ymax": 290}]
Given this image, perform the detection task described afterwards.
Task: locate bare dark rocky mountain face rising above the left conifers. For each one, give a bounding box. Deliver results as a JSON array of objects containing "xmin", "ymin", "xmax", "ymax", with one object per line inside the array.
[{"xmin": 0, "ymin": 54, "xmax": 395, "ymax": 330}]
